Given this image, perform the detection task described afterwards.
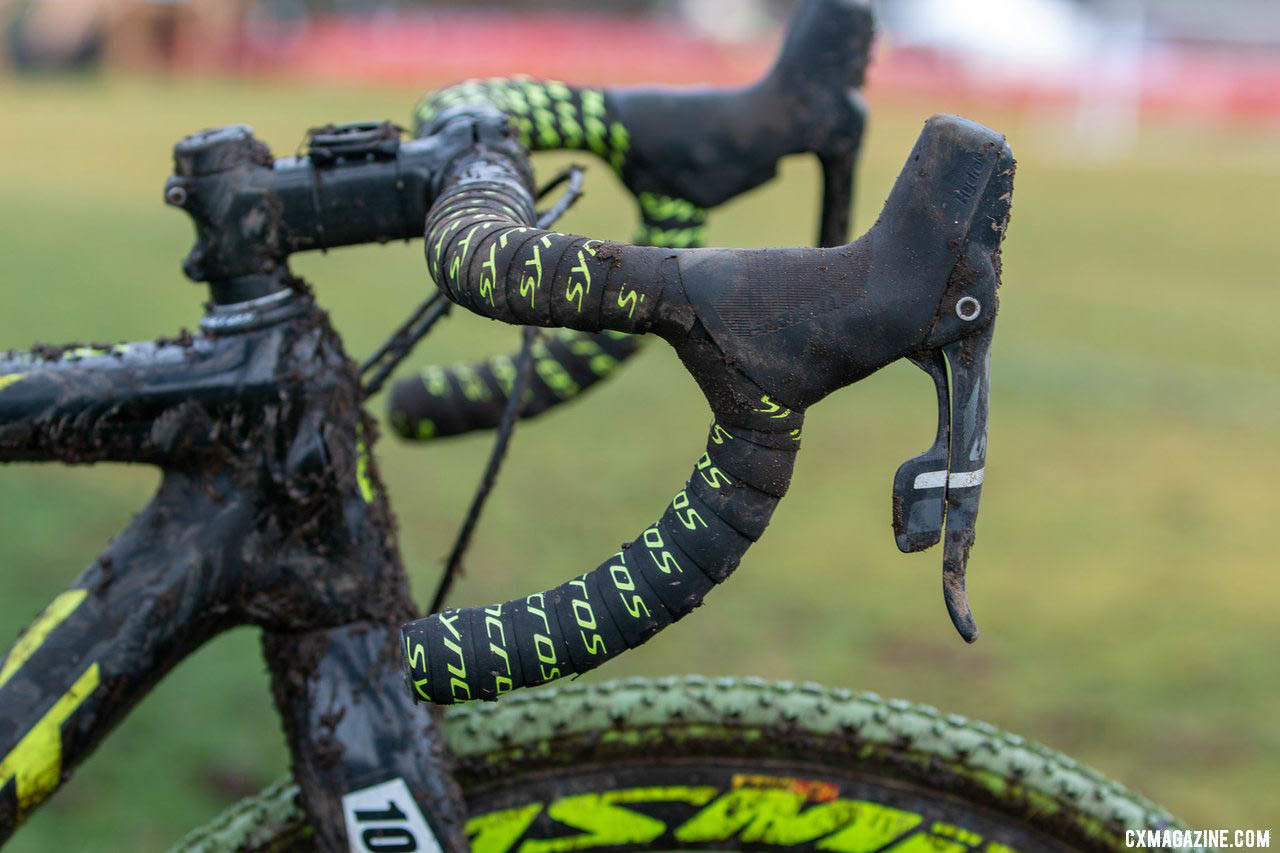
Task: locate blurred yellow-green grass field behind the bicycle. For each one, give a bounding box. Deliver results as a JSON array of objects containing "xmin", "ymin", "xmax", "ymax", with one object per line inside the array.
[{"xmin": 0, "ymin": 78, "xmax": 1280, "ymax": 850}]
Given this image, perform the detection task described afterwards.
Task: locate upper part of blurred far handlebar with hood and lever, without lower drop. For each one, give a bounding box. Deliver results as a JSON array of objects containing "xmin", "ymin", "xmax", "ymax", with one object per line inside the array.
[{"xmin": 416, "ymin": 0, "xmax": 873, "ymax": 248}]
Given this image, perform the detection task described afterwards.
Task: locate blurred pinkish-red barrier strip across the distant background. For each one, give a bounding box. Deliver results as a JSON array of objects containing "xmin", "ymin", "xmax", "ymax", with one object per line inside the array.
[{"xmin": 239, "ymin": 10, "xmax": 1280, "ymax": 120}]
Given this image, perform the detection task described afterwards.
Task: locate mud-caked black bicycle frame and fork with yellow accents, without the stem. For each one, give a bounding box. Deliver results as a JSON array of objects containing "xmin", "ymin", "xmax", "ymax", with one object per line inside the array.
[{"xmin": 0, "ymin": 292, "xmax": 462, "ymax": 849}]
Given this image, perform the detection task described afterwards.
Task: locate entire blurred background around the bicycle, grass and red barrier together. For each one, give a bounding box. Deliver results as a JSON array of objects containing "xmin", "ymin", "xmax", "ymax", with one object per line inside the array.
[{"xmin": 0, "ymin": 0, "xmax": 1280, "ymax": 850}]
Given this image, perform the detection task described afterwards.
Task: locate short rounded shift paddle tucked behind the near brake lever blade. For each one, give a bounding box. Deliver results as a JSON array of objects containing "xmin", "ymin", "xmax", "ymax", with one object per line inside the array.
[{"xmin": 893, "ymin": 350, "xmax": 951, "ymax": 553}]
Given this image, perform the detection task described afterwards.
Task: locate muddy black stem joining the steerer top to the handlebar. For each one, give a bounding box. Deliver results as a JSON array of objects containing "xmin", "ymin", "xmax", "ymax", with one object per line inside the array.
[{"xmin": 164, "ymin": 109, "xmax": 517, "ymax": 305}]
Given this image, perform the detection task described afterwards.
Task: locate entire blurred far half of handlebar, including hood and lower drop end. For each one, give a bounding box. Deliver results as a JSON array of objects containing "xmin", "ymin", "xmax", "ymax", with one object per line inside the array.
[{"xmin": 388, "ymin": 0, "xmax": 873, "ymax": 441}]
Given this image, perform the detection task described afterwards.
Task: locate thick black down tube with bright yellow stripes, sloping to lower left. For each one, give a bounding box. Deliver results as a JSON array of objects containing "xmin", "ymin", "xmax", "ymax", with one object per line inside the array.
[{"xmin": 0, "ymin": 474, "xmax": 252, "ymax": 843}]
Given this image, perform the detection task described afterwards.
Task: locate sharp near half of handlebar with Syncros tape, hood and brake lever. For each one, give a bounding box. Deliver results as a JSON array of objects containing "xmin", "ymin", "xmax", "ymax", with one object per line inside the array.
[{"xmin": 402, "ymin": 113, "xmax": 1014, "ymax": 703}]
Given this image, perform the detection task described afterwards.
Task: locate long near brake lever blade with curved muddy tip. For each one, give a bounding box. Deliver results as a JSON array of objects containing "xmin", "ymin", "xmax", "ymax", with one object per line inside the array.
[{"xmin": 942, "ymin": 323, "xmax": 995, "ymax": 643}]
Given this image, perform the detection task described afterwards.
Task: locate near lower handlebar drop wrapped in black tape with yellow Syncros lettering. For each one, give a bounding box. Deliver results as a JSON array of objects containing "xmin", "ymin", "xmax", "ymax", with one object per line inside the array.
[{"xmin": 402, "ymin": 412, "xmax": 800, "ymax": 704}]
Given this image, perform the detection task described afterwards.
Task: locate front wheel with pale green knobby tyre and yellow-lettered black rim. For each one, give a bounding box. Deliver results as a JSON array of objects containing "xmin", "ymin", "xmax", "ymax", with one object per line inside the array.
[{"xmin": 177, "ymin": 676, "xmax": 1198, "ymax": 853}]
